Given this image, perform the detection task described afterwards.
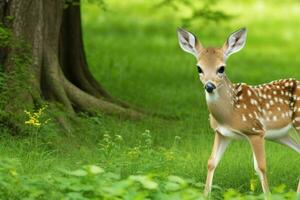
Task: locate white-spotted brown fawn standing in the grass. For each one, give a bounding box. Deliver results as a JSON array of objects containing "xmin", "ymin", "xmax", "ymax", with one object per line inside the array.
[{"xmin": 177, "ymin": 28, "xmax": 300, "ymax": 196}]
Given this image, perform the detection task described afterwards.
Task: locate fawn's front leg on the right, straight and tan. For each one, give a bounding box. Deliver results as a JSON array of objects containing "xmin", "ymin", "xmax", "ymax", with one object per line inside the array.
[{"xmin": 249, "ymin": 135, "xmax": 269, "ymax": 194}]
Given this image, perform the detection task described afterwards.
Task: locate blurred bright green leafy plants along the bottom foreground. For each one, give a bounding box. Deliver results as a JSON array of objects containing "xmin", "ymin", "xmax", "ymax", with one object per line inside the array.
[{"xmin": 0, "ymin": 158, "xmax": 296, "ymax": 200}]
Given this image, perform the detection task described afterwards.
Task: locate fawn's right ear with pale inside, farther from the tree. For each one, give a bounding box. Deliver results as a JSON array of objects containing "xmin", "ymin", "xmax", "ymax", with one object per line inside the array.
[{"xmin": 223, "ymin": 28, "xmax": 247, "ymax": 58}]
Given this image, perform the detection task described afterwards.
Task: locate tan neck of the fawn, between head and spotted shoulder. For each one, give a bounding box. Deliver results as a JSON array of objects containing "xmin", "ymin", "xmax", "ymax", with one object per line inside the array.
[{"xmin": 205, "ymin": 76, "xmax": 235, "ymax": 124}]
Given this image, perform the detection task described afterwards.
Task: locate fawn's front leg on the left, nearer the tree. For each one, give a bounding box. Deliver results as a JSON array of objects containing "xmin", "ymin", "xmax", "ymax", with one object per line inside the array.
[{"xmin": 204, "ymin": 132, "xmax": 230, "ymax": 196}]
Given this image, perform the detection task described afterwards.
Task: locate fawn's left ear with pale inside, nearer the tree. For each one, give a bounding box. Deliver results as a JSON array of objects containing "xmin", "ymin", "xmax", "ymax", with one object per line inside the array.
[{"xmin": 177, "ymin": 28, "xmax": 201, "ymax": 58}]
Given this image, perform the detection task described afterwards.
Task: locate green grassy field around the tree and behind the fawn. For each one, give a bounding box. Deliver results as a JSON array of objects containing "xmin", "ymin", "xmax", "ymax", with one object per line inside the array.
[{"xmin": 0, "ymin": 0, "xmax": 300, "ymax": 198}]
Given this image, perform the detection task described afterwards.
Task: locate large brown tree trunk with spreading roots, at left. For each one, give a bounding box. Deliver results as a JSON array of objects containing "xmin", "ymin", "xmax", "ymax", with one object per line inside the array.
[{"xmin": 0, "ymin": 0, "xmax": 143, "ymax": 134}]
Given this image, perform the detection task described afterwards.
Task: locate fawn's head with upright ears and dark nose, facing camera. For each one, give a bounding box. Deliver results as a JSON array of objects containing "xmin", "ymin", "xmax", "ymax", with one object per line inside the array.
[{"xmin": 177, "ymin": 28, "xmax": 247, "ymax": 94}]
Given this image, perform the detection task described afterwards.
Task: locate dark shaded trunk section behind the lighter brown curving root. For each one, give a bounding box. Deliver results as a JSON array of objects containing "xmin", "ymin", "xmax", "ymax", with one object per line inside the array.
[{"xmin": 59, "ymin": 2, "xmax": 145, "ymax": 112}]
